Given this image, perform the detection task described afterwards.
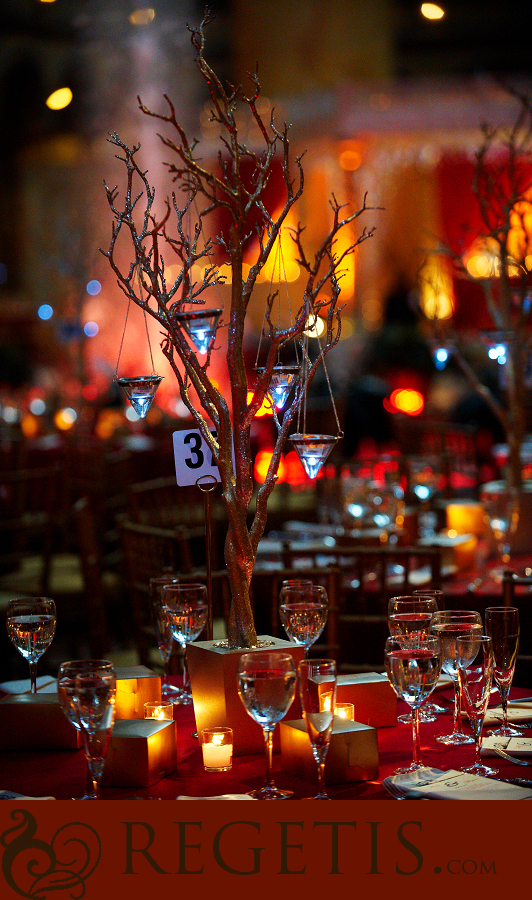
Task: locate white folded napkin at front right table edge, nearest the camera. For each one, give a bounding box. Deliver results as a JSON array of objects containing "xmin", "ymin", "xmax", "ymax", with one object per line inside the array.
[{"xmin": 383, "ymin": 768, "xmax": 532, "ymax": 800}]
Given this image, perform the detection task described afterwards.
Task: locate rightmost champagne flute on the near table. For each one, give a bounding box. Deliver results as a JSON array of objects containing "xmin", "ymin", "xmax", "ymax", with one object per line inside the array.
[{"xmin": 484, "ymin": 606, "xmax": 521, "ymax": 737}]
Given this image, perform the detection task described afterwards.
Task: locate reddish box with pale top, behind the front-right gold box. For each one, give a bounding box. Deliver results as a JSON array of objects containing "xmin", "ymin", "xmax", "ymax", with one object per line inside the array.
[{"xmin": 336, "ymin": 672, "xmax": 397, "ymax": 728}]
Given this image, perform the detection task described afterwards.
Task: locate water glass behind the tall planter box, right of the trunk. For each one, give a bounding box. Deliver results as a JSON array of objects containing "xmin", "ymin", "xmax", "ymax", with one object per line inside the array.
[{"xmin": 279, "ymin": 581, "xmax": 329, "ymax": 659}]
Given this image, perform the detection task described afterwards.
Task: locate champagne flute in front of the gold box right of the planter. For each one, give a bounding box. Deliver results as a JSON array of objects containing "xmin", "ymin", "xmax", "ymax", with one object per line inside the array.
[{"xmin": 298, "ymin": 659, "xmax": 336, "ymax": 800}]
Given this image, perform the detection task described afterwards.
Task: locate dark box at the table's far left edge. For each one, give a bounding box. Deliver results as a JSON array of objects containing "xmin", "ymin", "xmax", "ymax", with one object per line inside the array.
[{"xmin": 0, "ymin": 691, "xmax": 82, "ymax": 750}]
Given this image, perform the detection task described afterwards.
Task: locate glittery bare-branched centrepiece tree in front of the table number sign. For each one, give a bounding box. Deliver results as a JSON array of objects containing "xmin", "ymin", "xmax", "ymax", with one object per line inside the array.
[{"xmin": 102, "ymin": 13, "xmax": 373, "ymax": 647}]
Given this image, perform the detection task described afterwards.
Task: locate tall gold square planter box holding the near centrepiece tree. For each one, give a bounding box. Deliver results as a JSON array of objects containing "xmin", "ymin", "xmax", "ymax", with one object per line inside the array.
[{"xmin": 187, "ymin": 635, "xmax": 304, "ymax": 756}]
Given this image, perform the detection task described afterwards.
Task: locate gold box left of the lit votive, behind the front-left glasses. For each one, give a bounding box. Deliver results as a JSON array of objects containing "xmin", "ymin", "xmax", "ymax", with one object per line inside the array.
[{"xmin": 102, "ymin": 719, "xmax": 177, "ymax": 787}]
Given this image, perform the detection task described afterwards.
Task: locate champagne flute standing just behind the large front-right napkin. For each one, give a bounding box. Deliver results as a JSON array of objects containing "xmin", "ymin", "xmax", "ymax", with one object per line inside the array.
[{"xmin": 456, "ymin": 634, "xmax": 499, "ymax": 775}]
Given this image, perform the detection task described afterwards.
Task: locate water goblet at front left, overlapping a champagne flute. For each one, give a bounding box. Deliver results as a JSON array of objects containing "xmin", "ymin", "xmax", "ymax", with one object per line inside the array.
[{"xmin": 57, "ymin": 659, "xmax": 116, "ymax": 800}]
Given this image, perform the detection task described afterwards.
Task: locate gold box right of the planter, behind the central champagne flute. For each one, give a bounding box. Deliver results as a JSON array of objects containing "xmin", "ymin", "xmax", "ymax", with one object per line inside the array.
[{"xmin": 279, "ymin": 716, "xmax": 379, "ymax": 784}]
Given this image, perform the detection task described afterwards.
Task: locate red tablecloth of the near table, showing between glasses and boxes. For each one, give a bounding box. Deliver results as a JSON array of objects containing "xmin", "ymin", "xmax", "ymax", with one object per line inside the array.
[{"xmin": 0, "ymin": 687, "xmax": 532, "ymax": 802}]
